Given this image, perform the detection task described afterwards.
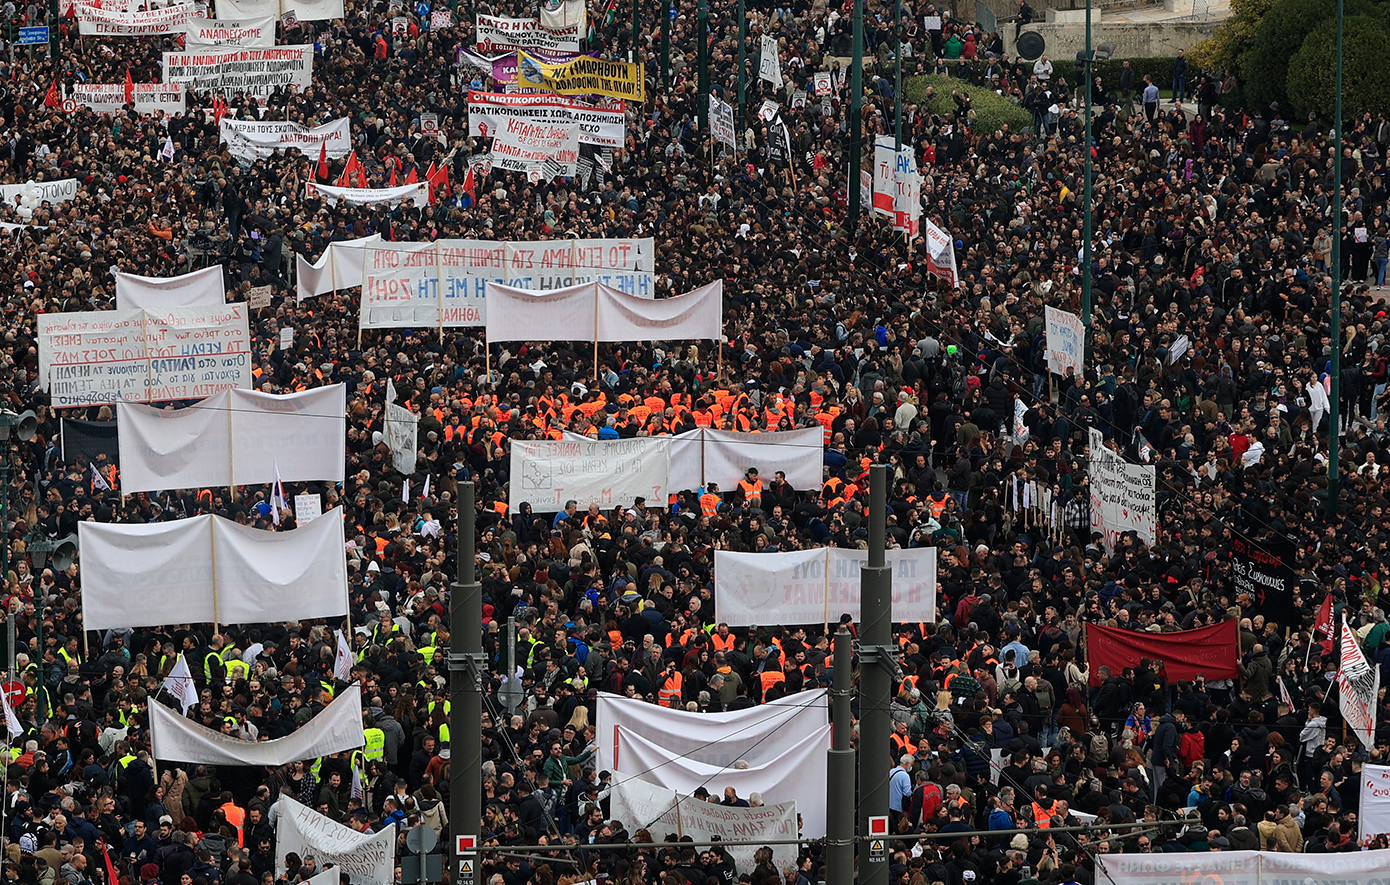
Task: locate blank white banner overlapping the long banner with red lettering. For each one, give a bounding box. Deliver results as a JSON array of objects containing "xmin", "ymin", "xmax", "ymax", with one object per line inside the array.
[{"xmin": 487, "ymin": 279, "xmax": 724, "ymax": 342}]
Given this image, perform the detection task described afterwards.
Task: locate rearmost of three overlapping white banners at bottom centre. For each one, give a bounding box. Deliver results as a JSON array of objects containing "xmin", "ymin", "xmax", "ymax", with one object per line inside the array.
[{"xmin": 594, "ymin": 689, "xmax": 830, "ymax": 772}]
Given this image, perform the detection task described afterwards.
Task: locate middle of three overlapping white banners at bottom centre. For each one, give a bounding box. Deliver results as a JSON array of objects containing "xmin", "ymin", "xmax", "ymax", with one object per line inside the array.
[{"xmin": 613, "ymin": 725, "xmax": 831, "ymax": 839}]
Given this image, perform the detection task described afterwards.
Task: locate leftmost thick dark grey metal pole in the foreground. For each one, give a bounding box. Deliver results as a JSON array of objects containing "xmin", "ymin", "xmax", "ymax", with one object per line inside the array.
[{"xmin": 446, "ymin": 482, "xmax": 488, "ymax": 885}]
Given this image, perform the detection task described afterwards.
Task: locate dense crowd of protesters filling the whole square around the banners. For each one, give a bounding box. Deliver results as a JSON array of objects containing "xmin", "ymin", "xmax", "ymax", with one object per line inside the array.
[{"xmin": 0, "ymin": 0, "xmax": 1390, "ymax": 885}]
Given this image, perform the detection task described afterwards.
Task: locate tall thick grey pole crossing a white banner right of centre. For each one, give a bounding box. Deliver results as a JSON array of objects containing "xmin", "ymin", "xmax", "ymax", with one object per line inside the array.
[{"xmin": 859, "ymin": 466, "xmax": 898, "ymax": 885}]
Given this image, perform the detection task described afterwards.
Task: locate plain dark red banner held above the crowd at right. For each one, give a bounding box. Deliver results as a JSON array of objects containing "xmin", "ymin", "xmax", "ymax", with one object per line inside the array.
[{"xmin": 1086, "ymin": 621, "xmax": 1240, "ymax": 685}]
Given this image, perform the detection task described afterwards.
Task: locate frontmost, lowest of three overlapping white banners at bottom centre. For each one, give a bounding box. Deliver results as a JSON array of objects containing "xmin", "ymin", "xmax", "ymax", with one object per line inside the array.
[{"xmin": 609, "ymin": 778, "xmax": 799, "ymax": 870}]
